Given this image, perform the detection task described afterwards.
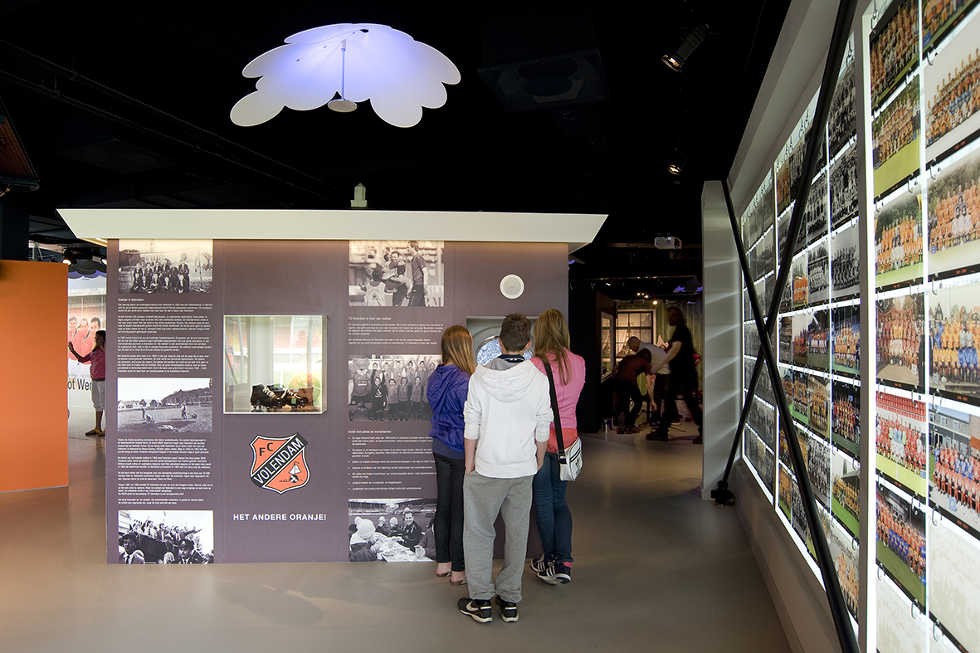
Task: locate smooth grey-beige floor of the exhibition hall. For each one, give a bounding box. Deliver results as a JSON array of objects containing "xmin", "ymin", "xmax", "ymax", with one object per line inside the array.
[{"xmin": 0, "ymin": 425, "xmax": 789, "ymax": 653}]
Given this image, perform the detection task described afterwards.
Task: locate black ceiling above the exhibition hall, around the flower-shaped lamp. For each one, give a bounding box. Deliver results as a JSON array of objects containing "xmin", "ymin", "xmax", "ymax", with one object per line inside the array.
[{"xmin": 0, "ymin": 0, "xmax": 788, "ymax": 296}]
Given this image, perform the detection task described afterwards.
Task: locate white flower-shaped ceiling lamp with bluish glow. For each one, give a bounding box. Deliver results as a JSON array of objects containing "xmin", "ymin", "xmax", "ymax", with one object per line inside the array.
[{"xmin": 231, "ymin": 23, "xmax": 460, "ymax": 127}]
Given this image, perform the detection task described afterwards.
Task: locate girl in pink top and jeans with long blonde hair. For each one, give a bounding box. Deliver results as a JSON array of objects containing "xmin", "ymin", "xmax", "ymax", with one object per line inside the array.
[{"xmin": 531, "ymin": 308, "xmax": 585, "ymax": 585}]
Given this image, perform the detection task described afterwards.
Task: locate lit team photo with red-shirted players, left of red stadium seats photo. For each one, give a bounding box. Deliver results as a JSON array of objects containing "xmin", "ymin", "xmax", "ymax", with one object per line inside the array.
[{"xmin": 875, "ymin": 392, "xmax": 928, "ymax": 499}]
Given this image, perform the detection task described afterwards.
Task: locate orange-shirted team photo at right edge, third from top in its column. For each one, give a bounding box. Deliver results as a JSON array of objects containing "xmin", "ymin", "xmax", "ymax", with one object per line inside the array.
[{"xmin": 928, "ymin": 148, "xmax": 980, "ymax": 278}]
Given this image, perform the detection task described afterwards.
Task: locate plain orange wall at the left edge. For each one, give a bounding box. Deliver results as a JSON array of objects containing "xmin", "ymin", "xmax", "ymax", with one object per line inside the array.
[{"xmin": 0, "ymin": 261, "xmax": 68, "ymax": 491}]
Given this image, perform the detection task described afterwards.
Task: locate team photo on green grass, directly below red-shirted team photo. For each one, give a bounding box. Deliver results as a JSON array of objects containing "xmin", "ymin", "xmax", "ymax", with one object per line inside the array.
[{"xmin": 876, "ymin": 483, "xmax": 926, "ymax": 610}]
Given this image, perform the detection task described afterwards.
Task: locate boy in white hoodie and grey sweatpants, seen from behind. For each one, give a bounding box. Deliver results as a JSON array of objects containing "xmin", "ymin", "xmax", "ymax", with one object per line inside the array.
[{"xmin": 458, "ymin": 314, "xmax": 552, "ymax": 623}]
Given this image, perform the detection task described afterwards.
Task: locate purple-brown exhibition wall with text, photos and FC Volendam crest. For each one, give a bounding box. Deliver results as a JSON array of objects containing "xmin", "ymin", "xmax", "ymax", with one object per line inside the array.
[{"xmin": 106, "ymin": 240, "xmax": 568, "ymax": 564}]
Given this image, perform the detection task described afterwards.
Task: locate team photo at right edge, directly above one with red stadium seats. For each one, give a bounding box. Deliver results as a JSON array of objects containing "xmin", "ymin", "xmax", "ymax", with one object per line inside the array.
[{"xmin": 929, "ymin": 276, "xmax": 980, "ymax": 405}]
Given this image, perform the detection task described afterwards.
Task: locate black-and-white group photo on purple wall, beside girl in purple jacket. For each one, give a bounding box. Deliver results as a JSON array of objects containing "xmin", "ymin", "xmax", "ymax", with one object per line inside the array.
[{"xmin": 347, "ymin": 354, "xmax": 441, "ymax": 422}]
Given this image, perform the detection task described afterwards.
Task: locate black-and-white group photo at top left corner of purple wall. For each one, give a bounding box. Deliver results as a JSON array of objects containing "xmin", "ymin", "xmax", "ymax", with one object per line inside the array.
[{"xmin": 119, "ymin": 240, "xmax": 214, "ymax": 295}]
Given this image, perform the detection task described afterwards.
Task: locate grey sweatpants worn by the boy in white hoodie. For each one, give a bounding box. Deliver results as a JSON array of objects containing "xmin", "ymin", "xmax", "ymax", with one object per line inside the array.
[{"xmin": 463, "ymin": 472, "xmax": 534, "ymax": 603}]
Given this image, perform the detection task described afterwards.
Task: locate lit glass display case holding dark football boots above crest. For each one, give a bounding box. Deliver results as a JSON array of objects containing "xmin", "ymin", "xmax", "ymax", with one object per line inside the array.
[{"xmin": 223, "ymin": 315, "xmax": 325, "ymax": 413}]
